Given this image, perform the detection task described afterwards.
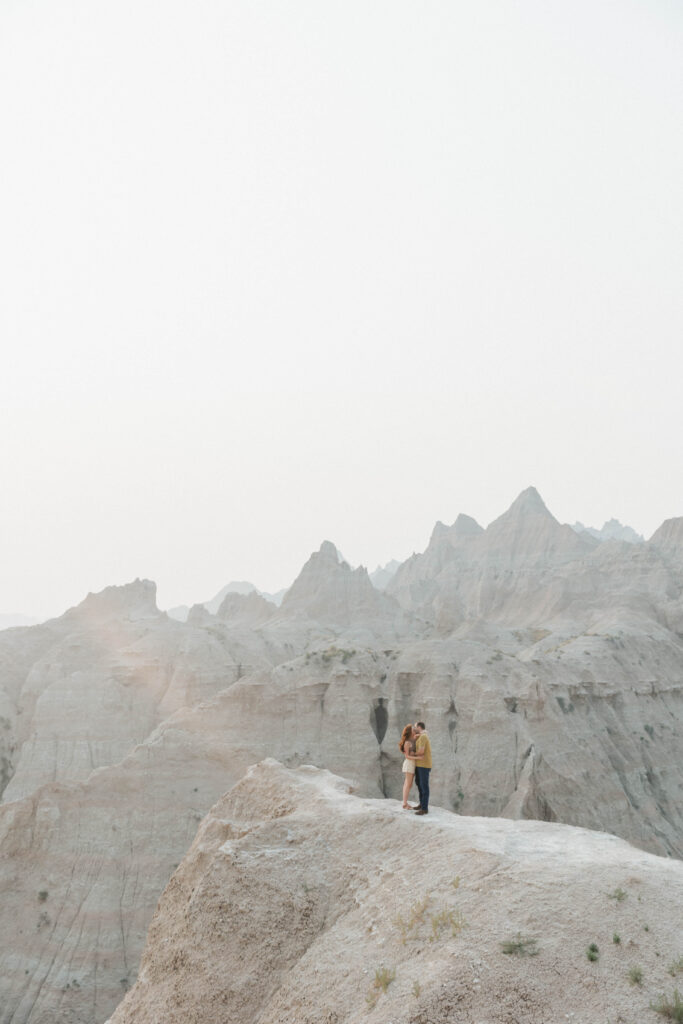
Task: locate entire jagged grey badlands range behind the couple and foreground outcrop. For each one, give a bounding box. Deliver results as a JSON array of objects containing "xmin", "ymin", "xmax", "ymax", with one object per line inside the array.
[{"xmin": 0, "ymin": 493, "xmax": 683, "ymax": 1024}]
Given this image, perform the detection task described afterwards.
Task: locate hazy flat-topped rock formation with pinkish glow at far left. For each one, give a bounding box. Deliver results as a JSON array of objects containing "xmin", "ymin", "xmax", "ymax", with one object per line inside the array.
[{"xmin": 0, "ymin": 581, "xmax": 271, "ymax": 802}]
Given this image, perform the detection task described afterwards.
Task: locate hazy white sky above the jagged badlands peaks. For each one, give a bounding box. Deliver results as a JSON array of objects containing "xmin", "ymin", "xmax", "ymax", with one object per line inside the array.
[{"xmin": 0, "ymin": 0, "xmax": 683, "ymax": 614}]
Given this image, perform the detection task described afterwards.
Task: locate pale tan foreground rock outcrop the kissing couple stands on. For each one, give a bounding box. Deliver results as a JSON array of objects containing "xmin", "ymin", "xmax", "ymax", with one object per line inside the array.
[{"xmin": 110, "ymin": 762, "xmax": 683, "ymax": 1024}]
